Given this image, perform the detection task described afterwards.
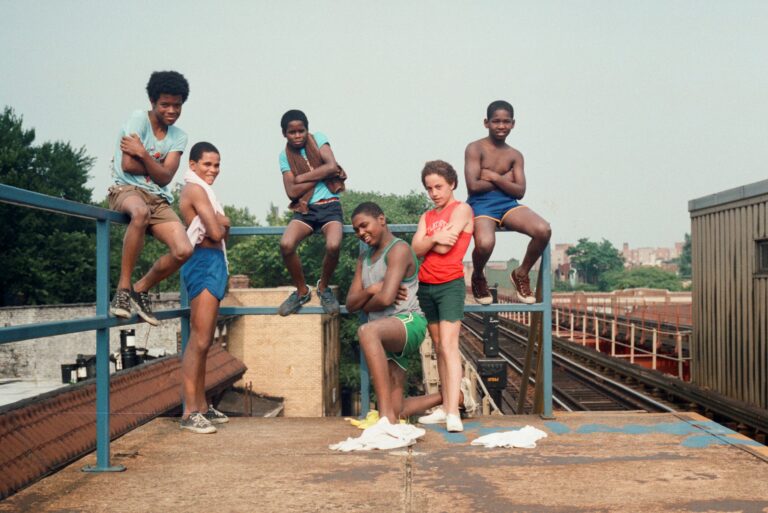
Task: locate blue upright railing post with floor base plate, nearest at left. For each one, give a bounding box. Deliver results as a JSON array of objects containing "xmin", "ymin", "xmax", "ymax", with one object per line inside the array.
[{"xmin": 83, "ymin": 220, "xmax": 125, "ymax": 472}]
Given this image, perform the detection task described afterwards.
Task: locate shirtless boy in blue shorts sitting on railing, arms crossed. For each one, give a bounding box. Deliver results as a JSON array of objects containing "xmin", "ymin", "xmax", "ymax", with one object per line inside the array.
[{"xmin": 464, "ymin": 100, "xmax": 552, "ymax": 305}]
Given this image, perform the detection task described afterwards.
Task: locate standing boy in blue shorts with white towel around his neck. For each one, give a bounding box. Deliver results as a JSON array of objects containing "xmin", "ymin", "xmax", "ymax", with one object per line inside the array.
[{"xmin": 179, "ymin": 142, "xmax": 230, "ymax": 433}]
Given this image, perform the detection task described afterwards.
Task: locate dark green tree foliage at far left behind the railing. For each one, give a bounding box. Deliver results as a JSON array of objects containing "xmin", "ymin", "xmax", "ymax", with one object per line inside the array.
[{"xmin": 0, "ymin": 107, "xmax": 96, "ymax": 305}]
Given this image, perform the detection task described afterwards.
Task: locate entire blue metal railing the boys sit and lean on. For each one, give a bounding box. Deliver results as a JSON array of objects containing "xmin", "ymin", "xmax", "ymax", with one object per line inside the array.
[{"xmin": 0, "ymin": 184, "xmax": 552, "ymax": 472}]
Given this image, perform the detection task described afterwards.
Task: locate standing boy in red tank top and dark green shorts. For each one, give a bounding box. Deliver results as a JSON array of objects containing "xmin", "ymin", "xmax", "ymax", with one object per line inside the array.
[{"xmin": 412, "ymin": 160, "xmax": 473, "ymax": 432}]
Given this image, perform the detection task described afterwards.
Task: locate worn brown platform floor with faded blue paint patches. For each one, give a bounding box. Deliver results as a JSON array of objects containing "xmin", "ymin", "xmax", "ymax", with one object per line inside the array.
[{"xmin": 0, "ymin": 413, "xmax": 768, "ymax": 513}]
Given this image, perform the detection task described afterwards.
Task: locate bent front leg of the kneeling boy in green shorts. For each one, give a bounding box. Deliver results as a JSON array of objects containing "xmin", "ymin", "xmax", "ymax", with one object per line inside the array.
[{"xmin": 357, "ymin": 317, "xmax": 406, "ymax": 423}]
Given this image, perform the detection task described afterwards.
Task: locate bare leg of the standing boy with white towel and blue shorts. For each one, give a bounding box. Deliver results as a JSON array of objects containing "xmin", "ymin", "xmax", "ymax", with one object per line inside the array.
[{"xmin": 181, "ymin": 289, "xmax": 219, "ymax": 418}]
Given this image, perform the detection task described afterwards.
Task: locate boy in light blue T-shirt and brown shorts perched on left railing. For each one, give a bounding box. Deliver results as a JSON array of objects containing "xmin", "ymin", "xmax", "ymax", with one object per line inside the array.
[{"xmin": 108, "ymin": 71, "xmax": 192, "ymax": 326}]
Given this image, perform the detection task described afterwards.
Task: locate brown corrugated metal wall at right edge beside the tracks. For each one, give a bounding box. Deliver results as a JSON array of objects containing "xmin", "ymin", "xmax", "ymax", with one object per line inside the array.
[{"xmin": 689, "ymin": 186, "xmax": 768, "ymax": 408}]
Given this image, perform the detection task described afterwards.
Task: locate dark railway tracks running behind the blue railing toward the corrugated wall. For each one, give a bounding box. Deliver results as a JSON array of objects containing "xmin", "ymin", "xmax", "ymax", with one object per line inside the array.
[{"xmin": 462, "ymin": 308, "xmax": 768, "ymax": 443}]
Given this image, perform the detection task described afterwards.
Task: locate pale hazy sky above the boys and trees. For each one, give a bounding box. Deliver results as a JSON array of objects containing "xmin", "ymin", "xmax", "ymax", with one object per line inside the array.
[{"xmin": 0, "ymin": 0, "xmax": 768, "ymax": 259}]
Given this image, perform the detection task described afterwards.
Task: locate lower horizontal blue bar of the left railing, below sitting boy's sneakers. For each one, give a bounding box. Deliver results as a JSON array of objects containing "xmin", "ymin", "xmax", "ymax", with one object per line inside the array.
[{"xmin": 0, "ymin": 308, "xmax": 189, "ymax": 344}]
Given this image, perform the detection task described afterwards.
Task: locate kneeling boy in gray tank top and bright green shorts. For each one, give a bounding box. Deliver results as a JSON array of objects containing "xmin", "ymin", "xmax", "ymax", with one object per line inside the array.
[{"xmin": 347, "ymin": 202, "xmax": 450, "ymax": 424}]
